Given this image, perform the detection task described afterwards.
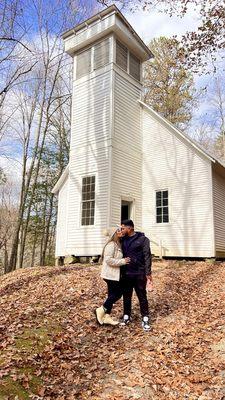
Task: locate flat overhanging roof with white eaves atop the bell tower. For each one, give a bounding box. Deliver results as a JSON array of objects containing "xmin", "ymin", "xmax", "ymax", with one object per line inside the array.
[{"xmin": 62, "ymin": 5, "xmax": 153, "ymax": 61}]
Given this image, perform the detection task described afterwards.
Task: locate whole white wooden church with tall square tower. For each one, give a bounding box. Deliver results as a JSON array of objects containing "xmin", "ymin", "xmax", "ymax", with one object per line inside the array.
[{"xmin": 53, "ymin": 6, "xmax": 225, "ymax": 258}]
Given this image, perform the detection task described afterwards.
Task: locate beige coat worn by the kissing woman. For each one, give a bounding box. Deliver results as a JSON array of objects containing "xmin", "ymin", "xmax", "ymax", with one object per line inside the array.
[{"xmin": 101, "ymin": 242, "xmax": 126, "ymax": 281}]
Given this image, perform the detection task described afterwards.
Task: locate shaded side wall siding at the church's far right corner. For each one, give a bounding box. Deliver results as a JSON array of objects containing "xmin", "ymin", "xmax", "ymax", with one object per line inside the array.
[{"xmin": 212, "ymin": 170, "xmax": 225, "ymax": 257}]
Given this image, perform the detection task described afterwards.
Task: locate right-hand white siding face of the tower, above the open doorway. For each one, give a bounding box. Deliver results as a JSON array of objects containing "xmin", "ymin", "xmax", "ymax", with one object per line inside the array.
[{"xmin": 111, "ymin": 73, "xmax": 142, "ymax": 229}]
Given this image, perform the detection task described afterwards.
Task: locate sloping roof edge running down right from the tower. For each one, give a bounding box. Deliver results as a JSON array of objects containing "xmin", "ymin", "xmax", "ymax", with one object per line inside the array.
[{"xmin": 139, "ymin": 100, "xmax": 225, "ymax": 169}]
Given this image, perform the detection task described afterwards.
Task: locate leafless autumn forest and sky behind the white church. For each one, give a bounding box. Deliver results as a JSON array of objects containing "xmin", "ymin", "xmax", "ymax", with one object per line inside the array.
[{"xmin": 0, "ymin": 0, "xmax": 225, "ymax": 273}]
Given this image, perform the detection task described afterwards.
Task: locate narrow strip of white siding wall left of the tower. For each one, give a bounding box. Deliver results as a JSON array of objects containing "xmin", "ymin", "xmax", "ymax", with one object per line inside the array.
[{"xmin": 56, "ymin": 177, "xmax": 69, "ymax": 257}]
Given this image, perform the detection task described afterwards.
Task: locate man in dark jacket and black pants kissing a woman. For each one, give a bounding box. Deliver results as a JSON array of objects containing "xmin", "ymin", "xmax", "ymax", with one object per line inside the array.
[{"xmin": 121, "ymin": 220, "xmax": 152, "ymax": 331}]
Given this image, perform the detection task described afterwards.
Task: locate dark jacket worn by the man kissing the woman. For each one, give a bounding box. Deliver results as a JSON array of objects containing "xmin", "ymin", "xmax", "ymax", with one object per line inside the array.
[{"xmin": 122, "ymin": 232, "xmax": 152, "ymax": 275}]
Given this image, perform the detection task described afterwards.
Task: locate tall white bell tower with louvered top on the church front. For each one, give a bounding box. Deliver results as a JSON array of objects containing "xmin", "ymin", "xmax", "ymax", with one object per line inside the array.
[{"xmin": 57, "ymin": 5, "xmax": 151, "ymax": 256}]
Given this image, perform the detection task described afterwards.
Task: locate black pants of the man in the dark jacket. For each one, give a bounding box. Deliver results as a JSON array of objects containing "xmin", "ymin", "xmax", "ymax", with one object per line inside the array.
[{"xmin": 121, "ymin": 275, "xmax": 149, "ymax": 317}]
